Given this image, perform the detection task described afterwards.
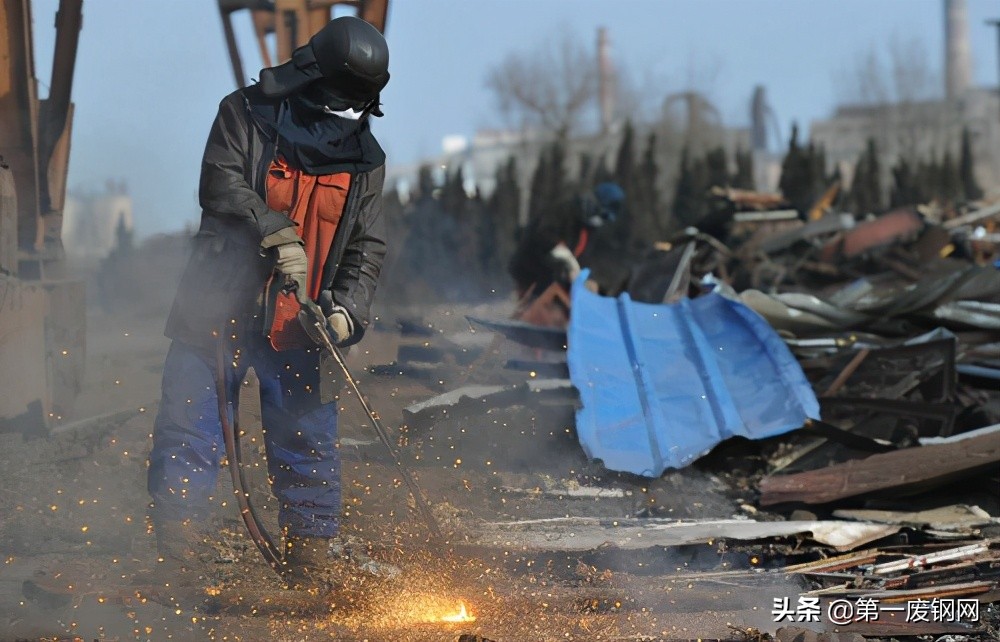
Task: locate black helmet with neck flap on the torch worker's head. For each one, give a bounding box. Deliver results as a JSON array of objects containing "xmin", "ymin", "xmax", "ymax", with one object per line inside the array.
[{"xmin": 260, "ymin": 16, "xmax": 389, "ymax": 105}]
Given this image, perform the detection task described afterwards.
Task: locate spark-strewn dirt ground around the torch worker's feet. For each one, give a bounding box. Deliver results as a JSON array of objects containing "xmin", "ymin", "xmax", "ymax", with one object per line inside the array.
[{"xmin": 0, "ymin": 292, "xmax": 844, "ymax": 642}]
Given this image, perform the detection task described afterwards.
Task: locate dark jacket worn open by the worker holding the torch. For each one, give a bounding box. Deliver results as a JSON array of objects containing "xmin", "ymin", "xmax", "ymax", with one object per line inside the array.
[{"xmin": 165, "ymin": 87, "xmax": 386, "ymax": 347}]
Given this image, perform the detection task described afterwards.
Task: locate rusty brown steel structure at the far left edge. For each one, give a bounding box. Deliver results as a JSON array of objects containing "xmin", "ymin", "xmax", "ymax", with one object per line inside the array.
[{"xmin": 0, "ymin": 0, "xmax": 85, "ymax": 432}]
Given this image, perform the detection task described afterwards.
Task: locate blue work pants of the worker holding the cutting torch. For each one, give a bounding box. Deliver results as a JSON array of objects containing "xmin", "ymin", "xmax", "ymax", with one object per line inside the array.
[{"xmin": 148, "ymin": 338, "xmax": 341, "ymax": 537}]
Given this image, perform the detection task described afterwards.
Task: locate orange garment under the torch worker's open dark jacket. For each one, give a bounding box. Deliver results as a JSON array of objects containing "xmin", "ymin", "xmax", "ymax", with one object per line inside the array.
[{"xmin": 267, "ymin": 156, "xmax": 351, "ymax": 351}]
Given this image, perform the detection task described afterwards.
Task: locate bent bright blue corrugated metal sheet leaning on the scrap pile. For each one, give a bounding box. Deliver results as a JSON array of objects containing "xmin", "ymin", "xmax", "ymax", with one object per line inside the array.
[{"xmin": 568, "ymin": 272, "xmax": 819, "ymax": 477}]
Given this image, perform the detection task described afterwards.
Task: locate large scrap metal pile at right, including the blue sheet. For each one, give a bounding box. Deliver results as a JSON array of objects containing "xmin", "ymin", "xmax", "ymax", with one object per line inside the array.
[{"xmin": 373, "ymin": 194, "xmax": 1000, "ymax": 640}]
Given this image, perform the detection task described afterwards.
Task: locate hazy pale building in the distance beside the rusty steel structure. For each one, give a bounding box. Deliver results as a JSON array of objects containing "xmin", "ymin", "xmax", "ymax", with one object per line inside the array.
[{"xmin": 63, "ymin": 181, "xmax": 133, "ymax": 259}]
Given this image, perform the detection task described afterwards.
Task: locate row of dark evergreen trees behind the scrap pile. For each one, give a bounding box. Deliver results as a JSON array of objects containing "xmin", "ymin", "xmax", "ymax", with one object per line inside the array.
[{"xmin": 387, "ymin": 124, "xmax": 982, "ymax": 300}]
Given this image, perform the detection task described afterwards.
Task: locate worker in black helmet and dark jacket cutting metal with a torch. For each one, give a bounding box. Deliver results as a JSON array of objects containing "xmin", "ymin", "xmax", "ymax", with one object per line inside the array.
[{"xmin": 148, "ymin": 17, "xmax": 389, "ymax": 588}]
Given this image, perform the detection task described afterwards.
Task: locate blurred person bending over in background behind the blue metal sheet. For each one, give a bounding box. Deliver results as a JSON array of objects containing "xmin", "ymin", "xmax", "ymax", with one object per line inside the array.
[{"xmin": 509, "ymin": 182, "xmax": 625, "ymax": 298}]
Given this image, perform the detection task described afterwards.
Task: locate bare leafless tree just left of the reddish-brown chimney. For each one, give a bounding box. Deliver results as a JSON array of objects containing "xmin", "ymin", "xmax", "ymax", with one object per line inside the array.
[{"xmin": 486, "ymin": 31, "xmax": 598, "ymax": 140}]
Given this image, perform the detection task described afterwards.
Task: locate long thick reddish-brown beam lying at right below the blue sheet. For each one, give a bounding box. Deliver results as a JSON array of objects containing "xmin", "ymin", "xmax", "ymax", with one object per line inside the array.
[{"xmin": 760, "ymin": 424, "xmax": 1000, "ymax": 506}]
